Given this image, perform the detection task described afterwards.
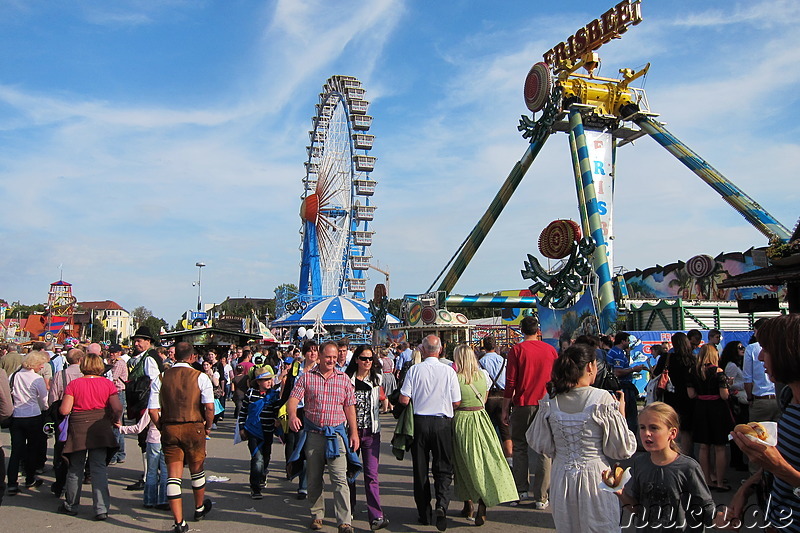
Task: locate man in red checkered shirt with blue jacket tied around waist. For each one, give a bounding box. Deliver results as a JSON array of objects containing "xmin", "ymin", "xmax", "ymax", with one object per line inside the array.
[{"xmin": 286, "ymin": 342, "xmax": 359, "ymax": 533}]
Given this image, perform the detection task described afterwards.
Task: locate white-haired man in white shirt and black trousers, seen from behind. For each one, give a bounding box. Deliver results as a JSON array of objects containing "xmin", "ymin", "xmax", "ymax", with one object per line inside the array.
[{"xmin": 400, "ymin": 335, "xmax": 461, "ymax": 531}]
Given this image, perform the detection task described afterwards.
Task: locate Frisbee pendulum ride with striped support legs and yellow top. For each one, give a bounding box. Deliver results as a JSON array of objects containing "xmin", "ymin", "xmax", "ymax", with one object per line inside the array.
[{"xmin": 422, "ymin": 0, "xmax": 791, "ymax": 332}]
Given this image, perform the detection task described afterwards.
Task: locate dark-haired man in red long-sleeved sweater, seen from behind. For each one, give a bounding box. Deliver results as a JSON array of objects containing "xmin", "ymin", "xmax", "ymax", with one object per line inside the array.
[{"xmin": 502, "ymin": 316, "xmax": 558, "ymax": 509}]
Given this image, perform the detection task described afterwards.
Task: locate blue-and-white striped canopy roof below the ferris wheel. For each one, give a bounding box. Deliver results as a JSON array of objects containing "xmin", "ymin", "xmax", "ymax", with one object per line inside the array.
[{"xmin": 272, "ymin": 296, "xmax": 400, "ymax": 327}]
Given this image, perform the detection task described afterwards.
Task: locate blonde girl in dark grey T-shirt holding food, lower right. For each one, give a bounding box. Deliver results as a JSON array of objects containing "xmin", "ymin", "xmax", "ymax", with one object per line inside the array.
[{"xmin": 617, "ymin": 402, "xmax": 714, "ymax": 531}]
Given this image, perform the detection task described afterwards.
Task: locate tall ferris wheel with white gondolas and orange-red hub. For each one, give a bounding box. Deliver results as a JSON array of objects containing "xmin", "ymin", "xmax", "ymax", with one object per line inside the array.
[{"xmin": 298, "ymin": 76, "xmax": 376, "ymax": 300}]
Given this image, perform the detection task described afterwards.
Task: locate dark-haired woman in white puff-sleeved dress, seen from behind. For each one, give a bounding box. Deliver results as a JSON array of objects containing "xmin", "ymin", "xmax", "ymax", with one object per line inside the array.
[{"xmin": 527, "ymin": 344, "xmax": 636, "ymax": 533}]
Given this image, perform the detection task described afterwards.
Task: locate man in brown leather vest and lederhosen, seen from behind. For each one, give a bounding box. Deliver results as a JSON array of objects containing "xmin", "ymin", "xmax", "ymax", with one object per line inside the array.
[{"xmin": 148, "ymin": 341, "xmax": 214, "ymax": 533}]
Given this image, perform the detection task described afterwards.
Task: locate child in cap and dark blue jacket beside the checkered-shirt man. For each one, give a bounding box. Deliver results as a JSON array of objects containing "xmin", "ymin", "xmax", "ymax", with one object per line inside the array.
[{"xmin": 238, "ymin": 366, "xmax": 283, "ymax": 500}]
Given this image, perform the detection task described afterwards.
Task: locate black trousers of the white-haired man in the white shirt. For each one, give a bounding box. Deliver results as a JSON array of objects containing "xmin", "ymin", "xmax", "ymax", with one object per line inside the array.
[{"xmin": 411, "ymin": 415, "xmax": 453, "ymax": 523}]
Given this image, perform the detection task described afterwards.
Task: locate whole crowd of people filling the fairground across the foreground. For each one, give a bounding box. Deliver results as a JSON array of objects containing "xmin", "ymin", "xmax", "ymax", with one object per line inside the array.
[{"xmin": 0, "ymin": 315, "xmax": 800, "ymax": 533}]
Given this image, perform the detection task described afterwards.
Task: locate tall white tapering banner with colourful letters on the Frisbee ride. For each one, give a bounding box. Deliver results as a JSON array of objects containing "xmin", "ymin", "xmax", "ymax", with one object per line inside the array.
[{"xmin": 584, "ymin": 128, "xmax": 614, "ymax": 272}]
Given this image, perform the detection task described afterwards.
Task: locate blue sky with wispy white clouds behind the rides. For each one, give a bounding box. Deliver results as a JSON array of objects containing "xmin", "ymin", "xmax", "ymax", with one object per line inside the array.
[{"xmin": 0, "ymin": 0, "xmax": 800, "ymax": 324}]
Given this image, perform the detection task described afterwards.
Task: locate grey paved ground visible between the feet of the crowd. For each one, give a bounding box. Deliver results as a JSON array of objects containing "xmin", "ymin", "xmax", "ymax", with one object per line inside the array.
[{"xmin": 0, "ymin": 415, "xmax": 752, "ymax": 533}]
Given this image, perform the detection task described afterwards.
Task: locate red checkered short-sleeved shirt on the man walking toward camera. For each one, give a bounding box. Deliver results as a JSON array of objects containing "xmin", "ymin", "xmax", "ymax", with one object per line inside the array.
[{"xmin": 291, "ymin": 368, "xmax": 356, "ymax": 427}]
